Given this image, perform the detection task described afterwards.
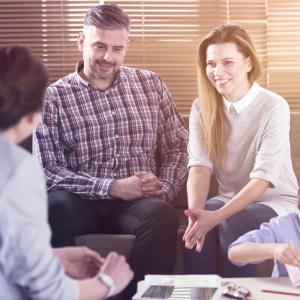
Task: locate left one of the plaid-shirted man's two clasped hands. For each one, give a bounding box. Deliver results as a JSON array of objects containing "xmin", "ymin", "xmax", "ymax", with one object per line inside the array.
[{"xmin": 111, "ymin": 175, "xmax": 144, "ymax": 201}]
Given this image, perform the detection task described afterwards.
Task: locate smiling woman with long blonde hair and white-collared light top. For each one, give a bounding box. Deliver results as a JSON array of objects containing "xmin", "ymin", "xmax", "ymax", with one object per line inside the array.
[{"xmin": 183, "ymin": 24, "xmax": 298, "ymax": 277}]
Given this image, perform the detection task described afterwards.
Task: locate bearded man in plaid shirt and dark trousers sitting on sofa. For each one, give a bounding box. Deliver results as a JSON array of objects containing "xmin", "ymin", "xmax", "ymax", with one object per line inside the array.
[{"xmin": 34, "ymin": 5, "xmax": 187, "ymax": 299}]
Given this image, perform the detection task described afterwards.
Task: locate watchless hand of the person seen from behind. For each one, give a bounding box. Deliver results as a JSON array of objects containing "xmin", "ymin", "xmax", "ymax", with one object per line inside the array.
[{"xmin": 53, "ymin": 247, "xmax": 104, "ymax": 279}]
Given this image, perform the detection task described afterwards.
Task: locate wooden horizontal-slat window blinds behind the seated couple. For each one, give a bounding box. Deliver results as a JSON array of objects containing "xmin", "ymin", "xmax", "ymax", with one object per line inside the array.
[{"xmin": 0, "ymin": 0, "xmax": 300, "ymax": 114}]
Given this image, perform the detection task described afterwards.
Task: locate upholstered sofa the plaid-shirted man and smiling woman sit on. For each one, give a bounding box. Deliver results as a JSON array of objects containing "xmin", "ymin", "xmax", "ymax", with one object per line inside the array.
[{"xmin": 22, "ymin": 112, "xmax": 300, "ymax": 276}]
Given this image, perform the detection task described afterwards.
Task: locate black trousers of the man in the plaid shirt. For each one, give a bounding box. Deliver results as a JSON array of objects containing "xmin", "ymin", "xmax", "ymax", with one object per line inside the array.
[{"xmin": 49, "ymin": 191, "xmax": 178, "ymax": 300}]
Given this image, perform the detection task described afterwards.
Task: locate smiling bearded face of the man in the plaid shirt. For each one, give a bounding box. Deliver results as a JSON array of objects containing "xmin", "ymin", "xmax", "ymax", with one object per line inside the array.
[{"xmin": 78, "ymin": 26, "xmax": 128, "ymax": 83}]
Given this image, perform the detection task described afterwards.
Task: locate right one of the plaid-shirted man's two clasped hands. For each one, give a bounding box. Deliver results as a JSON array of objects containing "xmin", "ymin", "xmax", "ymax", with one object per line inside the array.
[{"xmin": 135, "ymin": 171, "xmax": 166, "ymax": 199}]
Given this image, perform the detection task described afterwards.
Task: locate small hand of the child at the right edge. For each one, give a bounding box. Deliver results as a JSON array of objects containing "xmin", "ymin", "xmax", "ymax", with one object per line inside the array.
[{"xmin": 273, "ymin": 242, "xmax": 300, "ymax": 267}]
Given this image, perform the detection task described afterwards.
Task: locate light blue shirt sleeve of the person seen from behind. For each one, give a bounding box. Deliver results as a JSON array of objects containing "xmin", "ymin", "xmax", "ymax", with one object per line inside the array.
[{"xmin": 0, "ymin": 157, "xmax": 79, "ymax": 300}]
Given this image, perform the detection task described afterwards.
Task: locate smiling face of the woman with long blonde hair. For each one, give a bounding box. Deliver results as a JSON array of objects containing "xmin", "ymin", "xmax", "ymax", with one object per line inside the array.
[{"xmin": 206, "ymin": 43, "xmax": 252, "ymax": 102}]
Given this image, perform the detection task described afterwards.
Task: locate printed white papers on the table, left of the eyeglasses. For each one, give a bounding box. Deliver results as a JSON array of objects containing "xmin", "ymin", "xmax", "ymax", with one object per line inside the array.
[{"xmin": 133, "ymin": 275, "xmax": 221, "ymax": 300}]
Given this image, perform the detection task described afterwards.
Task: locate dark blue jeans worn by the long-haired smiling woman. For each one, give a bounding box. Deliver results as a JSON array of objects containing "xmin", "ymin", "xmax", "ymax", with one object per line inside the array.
[{"xmin": 185, "ymin": 199, "xmax": 277, "ymax": 277}]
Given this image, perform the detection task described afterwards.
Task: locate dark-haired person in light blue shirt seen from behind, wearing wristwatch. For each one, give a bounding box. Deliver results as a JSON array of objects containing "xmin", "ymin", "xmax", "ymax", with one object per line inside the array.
[{"xmin": 0, "ymin": 46, "xmax": 133, "ymax": 300}]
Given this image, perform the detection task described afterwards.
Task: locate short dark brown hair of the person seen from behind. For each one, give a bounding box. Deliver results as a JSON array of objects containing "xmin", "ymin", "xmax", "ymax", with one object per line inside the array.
[{"xmin": 0, "ymin": 46, "xmax": 48, "ymax": 130}]
